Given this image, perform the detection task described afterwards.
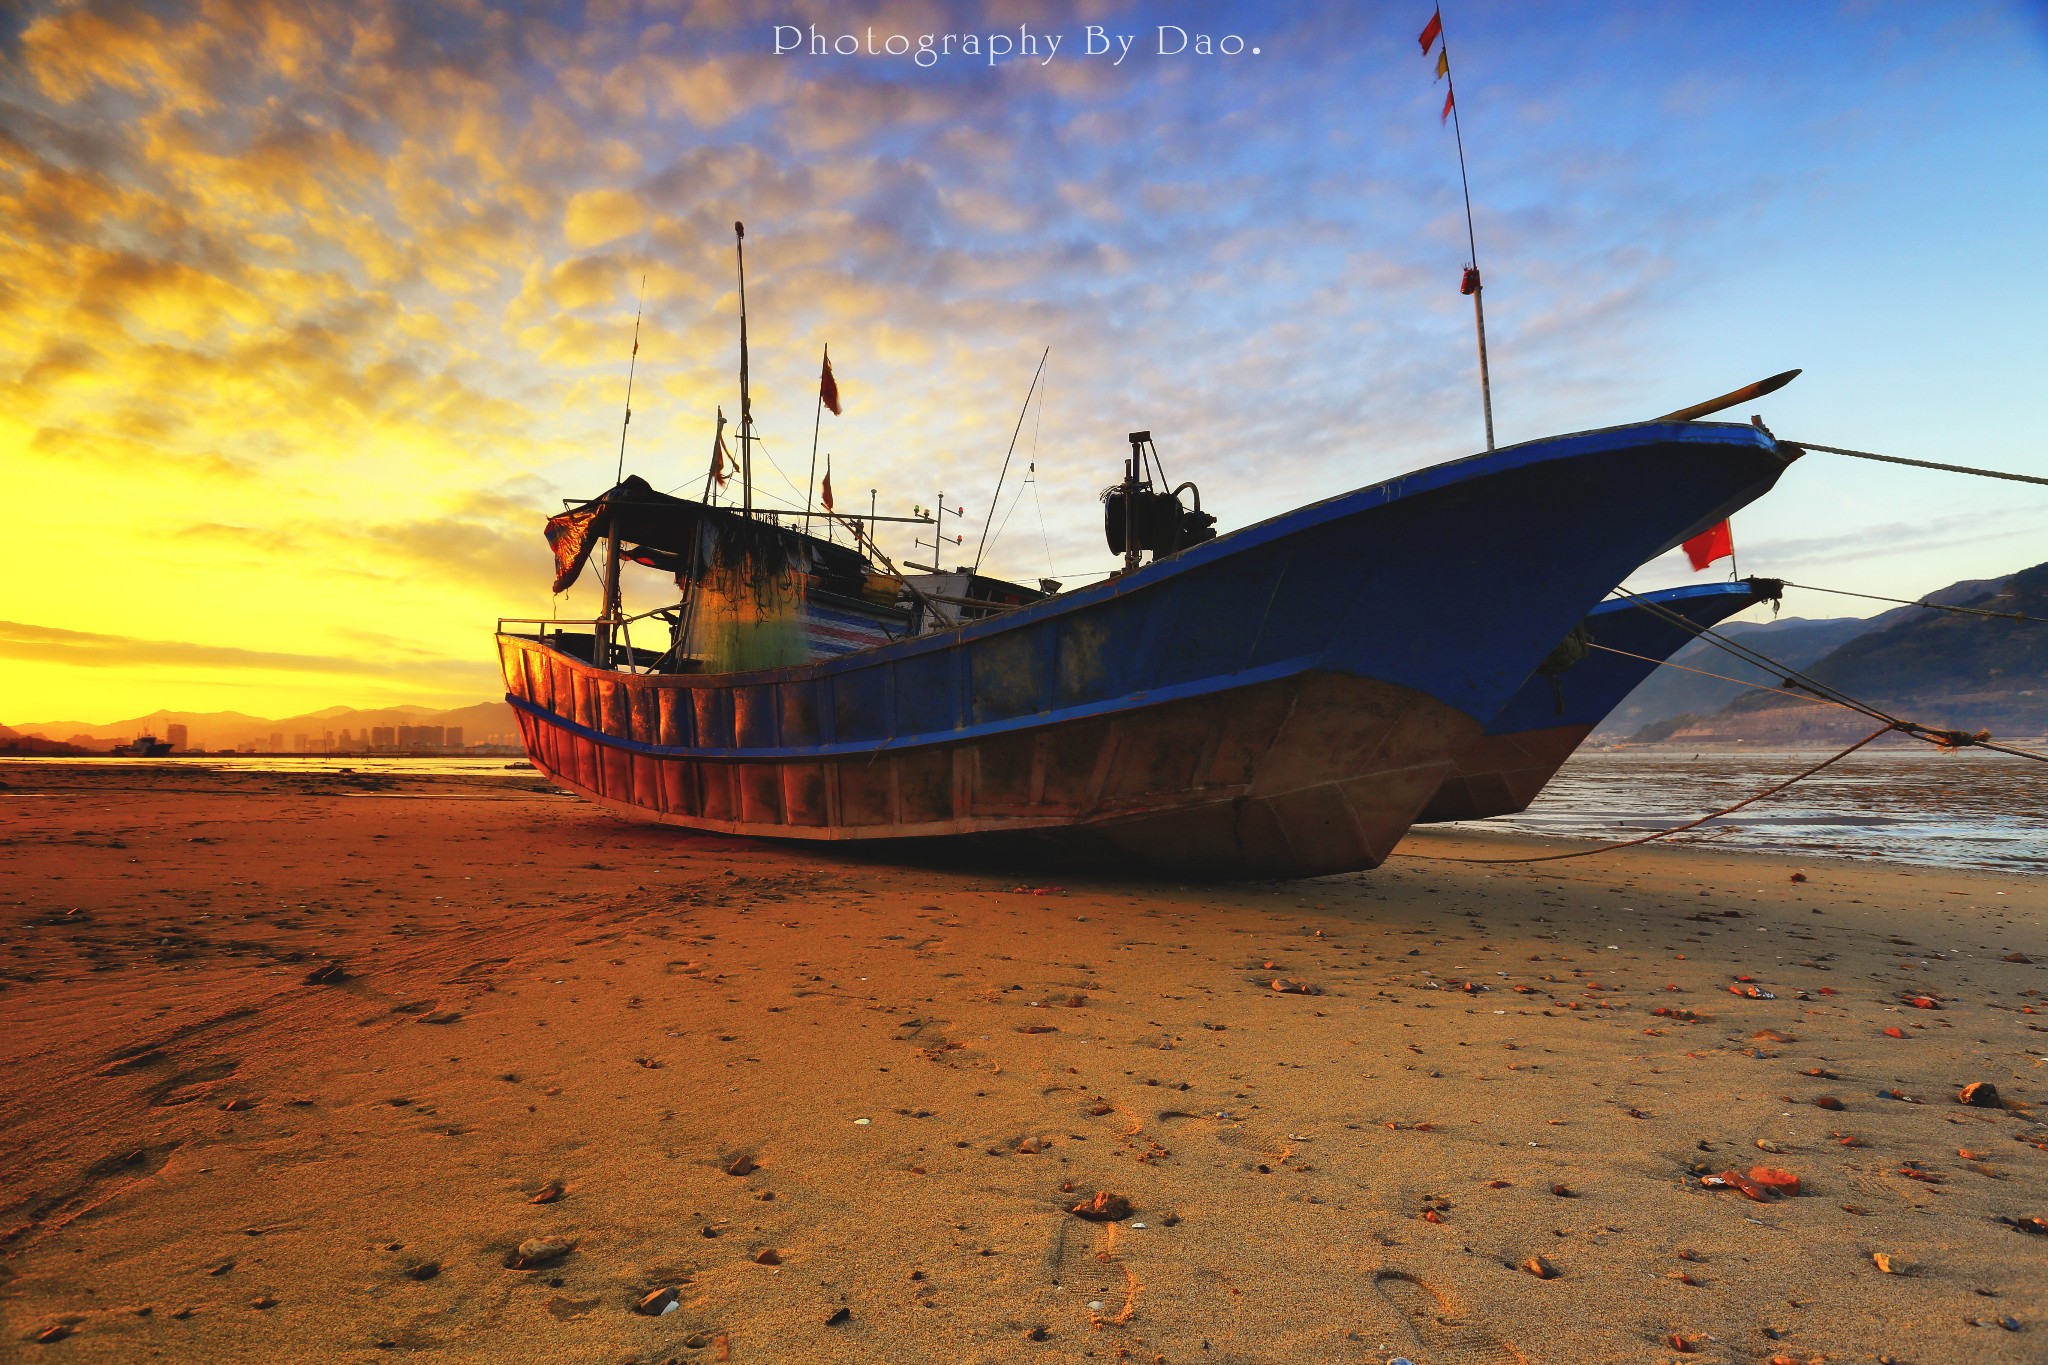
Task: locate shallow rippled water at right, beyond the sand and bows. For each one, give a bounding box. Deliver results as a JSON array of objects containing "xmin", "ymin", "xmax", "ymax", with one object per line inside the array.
[{"xmin": 1441, "ymin": 749, "xmax": 2048, "ymax": 872}]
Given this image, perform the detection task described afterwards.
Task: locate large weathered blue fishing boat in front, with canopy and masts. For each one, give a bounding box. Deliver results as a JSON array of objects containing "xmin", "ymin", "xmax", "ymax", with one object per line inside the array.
[{"xmin": 498, "ymin": 223, "xmax": 1796, "ymax": 878}]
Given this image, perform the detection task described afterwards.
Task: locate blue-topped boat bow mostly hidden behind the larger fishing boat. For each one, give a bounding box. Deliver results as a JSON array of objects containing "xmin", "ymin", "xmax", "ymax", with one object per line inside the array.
[{"xmin": 1415, "ymin": 577, "xmax": 1784, "ymax": 825}]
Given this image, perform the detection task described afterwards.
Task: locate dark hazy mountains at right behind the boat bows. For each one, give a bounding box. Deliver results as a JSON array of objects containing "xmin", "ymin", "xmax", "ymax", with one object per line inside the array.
[{"xmin": 1599, "ymin": 565, "xmax": 2048, "ymax": 745}]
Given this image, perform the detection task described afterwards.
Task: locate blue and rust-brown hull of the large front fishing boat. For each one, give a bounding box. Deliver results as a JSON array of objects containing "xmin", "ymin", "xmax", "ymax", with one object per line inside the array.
[{"xmin": 500, "ymin": 424, "xmax": 1788, "ymax": 876}]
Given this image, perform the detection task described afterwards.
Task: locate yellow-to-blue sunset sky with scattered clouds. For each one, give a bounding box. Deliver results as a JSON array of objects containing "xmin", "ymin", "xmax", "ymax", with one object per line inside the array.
[{"xmin": 0, "ymin": 0, "xmax": 2048, "ymax": 722}]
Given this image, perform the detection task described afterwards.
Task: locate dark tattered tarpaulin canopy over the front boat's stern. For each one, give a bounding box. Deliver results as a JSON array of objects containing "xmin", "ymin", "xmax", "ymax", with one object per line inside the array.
[{"xmin": 547, "ymin": 475, "xmax": 866, "ymax": 593}]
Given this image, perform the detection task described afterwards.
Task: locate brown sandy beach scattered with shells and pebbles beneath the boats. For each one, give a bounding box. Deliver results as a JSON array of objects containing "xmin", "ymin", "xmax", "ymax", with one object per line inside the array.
[{"xmin": 0, "ymin": 763, "xmax": 2048, "ymax": 1365}]
